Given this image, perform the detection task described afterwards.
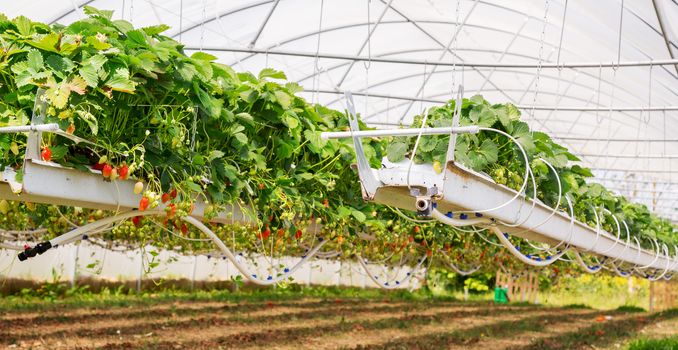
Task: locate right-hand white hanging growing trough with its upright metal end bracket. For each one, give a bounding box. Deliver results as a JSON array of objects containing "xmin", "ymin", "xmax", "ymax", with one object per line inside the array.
[{"xmin": 322, "ymin": 93, "xmax": 678, "ymax": 278}]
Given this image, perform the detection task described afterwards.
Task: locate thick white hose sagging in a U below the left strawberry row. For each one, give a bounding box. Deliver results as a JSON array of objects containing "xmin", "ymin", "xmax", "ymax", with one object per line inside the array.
[{"xmin": 183, "ymin": 216, "xmax": 328, "ymax": 286}]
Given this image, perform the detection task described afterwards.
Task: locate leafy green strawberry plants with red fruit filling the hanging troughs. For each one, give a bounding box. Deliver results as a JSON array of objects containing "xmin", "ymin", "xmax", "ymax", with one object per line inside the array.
[{"xmin": 0, "ymin": 6, "xmax": 678, "ymax": 276}]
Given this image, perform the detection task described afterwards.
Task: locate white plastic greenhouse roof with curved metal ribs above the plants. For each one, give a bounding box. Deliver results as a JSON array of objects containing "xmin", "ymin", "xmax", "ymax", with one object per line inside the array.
[{"xmin": 0, "ymin": 0, "xmax": 678, "ymax": 221}]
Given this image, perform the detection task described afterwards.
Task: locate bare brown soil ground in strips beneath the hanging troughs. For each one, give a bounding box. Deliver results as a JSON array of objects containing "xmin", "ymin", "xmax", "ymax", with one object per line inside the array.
[{"xmin": 0, "ymin": 299, "xmax": 678, "ymax": 350}]
